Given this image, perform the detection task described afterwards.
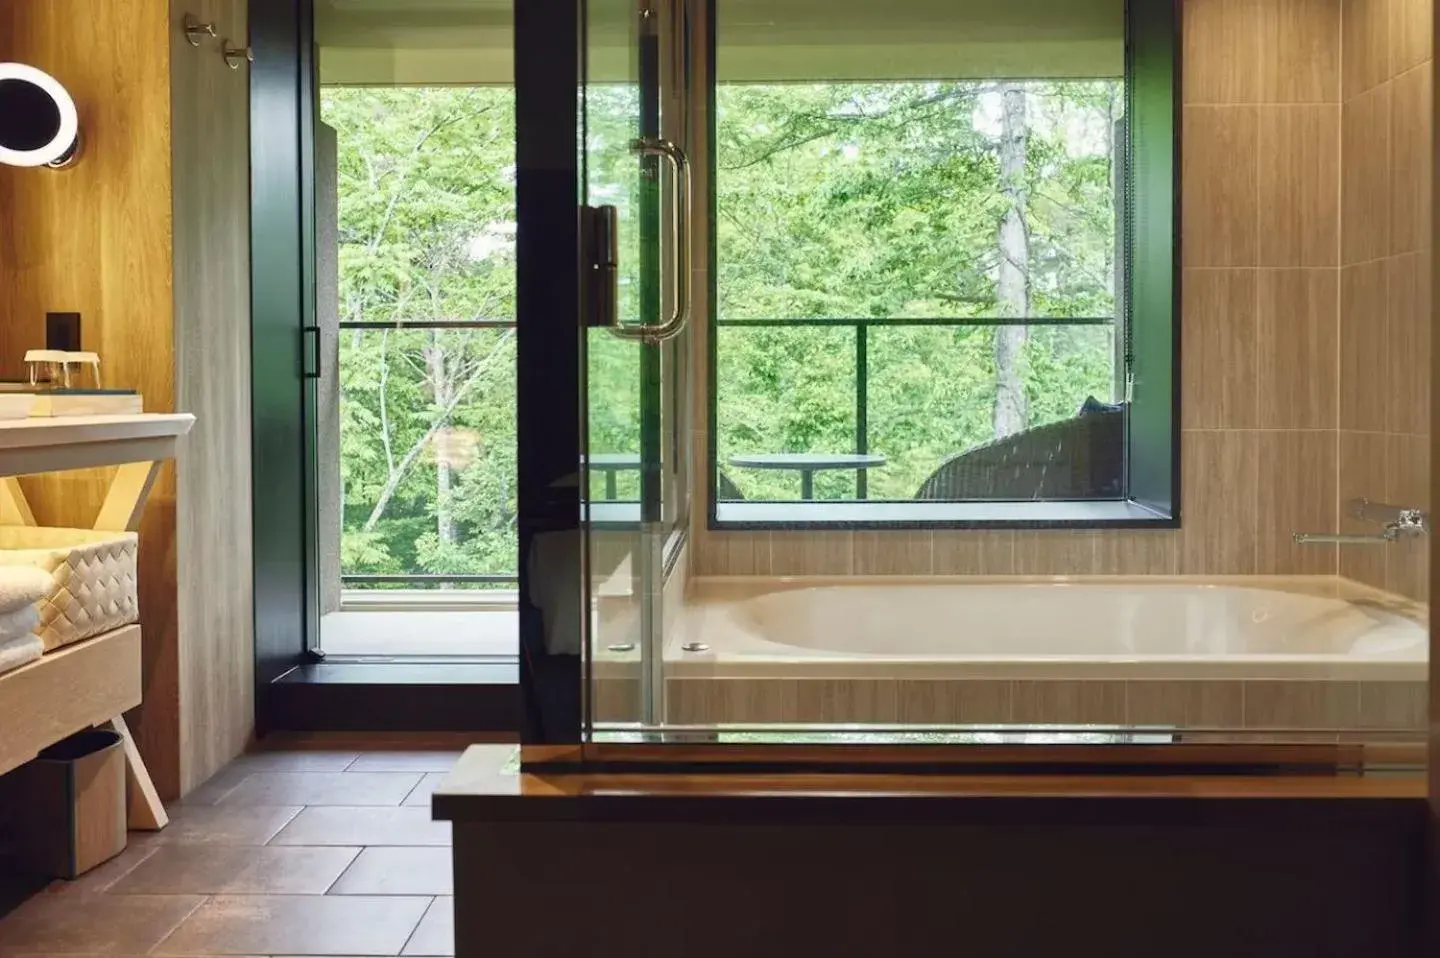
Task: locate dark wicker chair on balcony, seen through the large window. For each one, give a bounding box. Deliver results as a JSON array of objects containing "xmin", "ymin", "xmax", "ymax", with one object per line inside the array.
[{"xmin": 914, "ymin": 403, "xmax": 1125, "ymax": 501}]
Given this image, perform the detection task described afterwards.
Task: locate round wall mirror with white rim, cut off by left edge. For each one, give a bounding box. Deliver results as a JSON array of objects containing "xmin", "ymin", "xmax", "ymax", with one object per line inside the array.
[{"xmin": 0, "ymin": 63, "xmax": 81, "ymax": 167}]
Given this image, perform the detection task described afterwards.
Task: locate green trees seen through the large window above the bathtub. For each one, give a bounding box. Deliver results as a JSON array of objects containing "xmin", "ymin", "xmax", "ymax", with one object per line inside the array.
[{"xmin": 716, "ymin": 81, "xmax": 1123, "ymax": 500}]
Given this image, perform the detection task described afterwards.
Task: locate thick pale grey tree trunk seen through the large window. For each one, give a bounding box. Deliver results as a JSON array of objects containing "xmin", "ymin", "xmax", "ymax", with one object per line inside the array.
[{"xmin": 995, "ymin": 84, "xmax": 1030, "ymax": 438}]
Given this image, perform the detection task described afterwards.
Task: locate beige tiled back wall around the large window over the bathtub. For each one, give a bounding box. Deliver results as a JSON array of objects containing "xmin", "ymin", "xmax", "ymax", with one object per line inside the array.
[{"xmin": 691, "ymin": 0, "xmax": 1353, "ymax": 575}]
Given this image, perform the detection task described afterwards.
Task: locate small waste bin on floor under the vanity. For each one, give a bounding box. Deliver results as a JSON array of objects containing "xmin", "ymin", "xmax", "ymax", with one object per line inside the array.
[{"xmin": 16, "ymin": 729, "xmax": 127, "ymax": 879}]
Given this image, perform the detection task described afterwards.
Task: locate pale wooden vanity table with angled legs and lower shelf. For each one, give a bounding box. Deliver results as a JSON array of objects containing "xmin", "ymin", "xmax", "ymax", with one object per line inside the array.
[{"xmin": 0, "ymin": 413, "xmax": 194, "ymax": 830}]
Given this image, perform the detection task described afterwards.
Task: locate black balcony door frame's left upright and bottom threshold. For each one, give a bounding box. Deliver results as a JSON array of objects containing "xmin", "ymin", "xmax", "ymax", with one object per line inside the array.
[{"xmin": 249, "ymin": 0, "xmax": 520, "ymax": 735}]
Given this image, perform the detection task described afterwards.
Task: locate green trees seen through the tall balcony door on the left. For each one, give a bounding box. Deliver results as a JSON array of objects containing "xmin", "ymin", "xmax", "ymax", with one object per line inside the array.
[{"xmin": 323, "ymin": 88, "xmax": 516, "ymax": 573}]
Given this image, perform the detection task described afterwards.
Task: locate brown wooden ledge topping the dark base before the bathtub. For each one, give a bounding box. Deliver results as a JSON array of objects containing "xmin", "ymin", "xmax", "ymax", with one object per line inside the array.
[{"xmin": 432, "ymin": 748, "xmax": 1426, "ymax": 827}]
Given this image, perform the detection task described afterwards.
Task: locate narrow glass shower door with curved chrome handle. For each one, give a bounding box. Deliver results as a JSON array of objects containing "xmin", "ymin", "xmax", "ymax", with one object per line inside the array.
[{"xmin": 582, "ymin": 0, "xmax": 690, "ymax": 729}]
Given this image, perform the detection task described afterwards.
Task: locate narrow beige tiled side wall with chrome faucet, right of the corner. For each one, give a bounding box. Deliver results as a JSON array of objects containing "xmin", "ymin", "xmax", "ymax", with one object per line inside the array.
[{"xmin": 1338, "ymin": 0, "xmax": 1434, "ymax": 599}]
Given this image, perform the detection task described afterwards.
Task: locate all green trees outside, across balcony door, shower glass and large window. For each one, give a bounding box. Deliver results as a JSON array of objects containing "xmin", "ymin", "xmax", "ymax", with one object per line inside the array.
[{"xmin": 323, "ymin": 82, "xmax": 1123, "ymax": 573}]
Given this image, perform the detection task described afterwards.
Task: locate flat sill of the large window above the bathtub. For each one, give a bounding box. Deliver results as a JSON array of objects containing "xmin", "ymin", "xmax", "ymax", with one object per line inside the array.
[{"xmin": 710, "ymin": 500, "xmax": 1179, "ymax": 532}]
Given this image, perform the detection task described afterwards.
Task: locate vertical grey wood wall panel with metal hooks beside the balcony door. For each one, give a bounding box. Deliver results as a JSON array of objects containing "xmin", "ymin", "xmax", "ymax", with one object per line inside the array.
[{"xmin": 170, "ymin": 0, "xmax": 255, "ymax": 791}]
